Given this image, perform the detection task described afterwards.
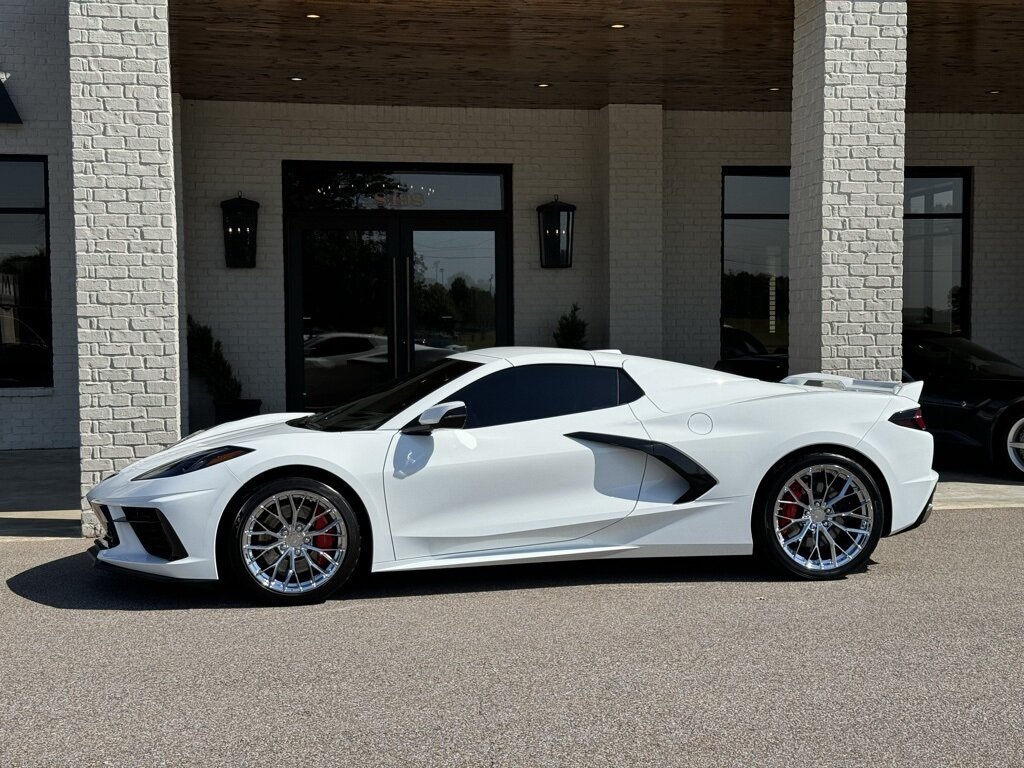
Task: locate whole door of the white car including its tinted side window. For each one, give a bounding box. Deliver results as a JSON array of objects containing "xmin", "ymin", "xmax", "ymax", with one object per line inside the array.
[{"xmin": 384, "ymin": 364, "xmax": 646, "ymax": 559}]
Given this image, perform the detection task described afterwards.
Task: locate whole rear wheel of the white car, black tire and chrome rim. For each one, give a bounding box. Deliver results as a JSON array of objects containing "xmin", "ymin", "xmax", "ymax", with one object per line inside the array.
[{"xmin": 752, "ymin": 453, "xmax": 888, "ymax": 581}]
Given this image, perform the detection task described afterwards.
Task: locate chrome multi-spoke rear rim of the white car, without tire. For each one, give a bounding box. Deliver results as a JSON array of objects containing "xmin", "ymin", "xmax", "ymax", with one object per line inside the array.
[{"xmin": 773, "ymin": 464, "xmax": 876, "ymax": 572}]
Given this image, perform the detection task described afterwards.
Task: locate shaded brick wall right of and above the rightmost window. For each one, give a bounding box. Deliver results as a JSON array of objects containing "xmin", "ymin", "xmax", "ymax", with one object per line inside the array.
[{"xmin": 906, "ymin": 115, "xmax": 1024, "ymax": 364}]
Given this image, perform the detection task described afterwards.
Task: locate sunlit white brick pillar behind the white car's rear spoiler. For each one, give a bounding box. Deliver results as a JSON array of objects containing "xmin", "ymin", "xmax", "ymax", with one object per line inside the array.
[{"xmin": 790, "ymin": 0, "xmax": 907, "ymax": 381}]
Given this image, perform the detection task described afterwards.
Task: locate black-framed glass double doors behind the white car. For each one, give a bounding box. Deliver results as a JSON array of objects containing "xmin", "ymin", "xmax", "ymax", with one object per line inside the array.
[{"xmin": 283, "ymin": 161, "xmax": 512, "ymax": 410}]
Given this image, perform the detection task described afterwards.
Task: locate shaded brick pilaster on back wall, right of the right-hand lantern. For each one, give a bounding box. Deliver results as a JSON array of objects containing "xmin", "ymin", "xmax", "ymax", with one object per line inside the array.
[{"xmin": 598, "ymin": 104, "xmax": 664, "ymax": 357}]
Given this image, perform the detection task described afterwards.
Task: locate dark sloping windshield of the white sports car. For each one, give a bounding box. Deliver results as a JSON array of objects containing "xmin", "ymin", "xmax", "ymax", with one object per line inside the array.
[{"xmin": 298, "ymin": 357, "xmax": 480, "ymax": 432}]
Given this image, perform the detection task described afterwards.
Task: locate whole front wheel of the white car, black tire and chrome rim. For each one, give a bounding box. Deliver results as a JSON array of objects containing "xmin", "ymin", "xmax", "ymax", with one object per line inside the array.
[{"xmin": 224, "ymin": 477, "xmax": 362, "ymax": 605}]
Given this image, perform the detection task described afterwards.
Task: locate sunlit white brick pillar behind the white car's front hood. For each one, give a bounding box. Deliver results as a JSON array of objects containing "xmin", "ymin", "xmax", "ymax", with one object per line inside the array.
[{"xmin": 69, "ymin": 0, "xmax": 180, "ymax": 535}]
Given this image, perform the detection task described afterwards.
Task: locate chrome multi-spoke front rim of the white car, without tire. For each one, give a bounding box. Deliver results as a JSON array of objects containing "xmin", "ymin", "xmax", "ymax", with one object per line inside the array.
[{"xmin": 240, "ymin": 490, "xmax": 348, "ymax": 595}]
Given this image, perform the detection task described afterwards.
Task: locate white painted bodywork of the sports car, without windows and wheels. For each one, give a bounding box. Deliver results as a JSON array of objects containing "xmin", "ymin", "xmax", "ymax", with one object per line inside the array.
[{"xmin": 88, "ymin": 347, "xmax": 937, "ymax": 580}]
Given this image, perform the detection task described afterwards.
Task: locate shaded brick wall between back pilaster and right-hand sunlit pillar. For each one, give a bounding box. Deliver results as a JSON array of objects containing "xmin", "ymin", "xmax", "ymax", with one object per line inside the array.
[{"xmin": 664, "ymin": 112, "xmax": 790, "ymax": 366}]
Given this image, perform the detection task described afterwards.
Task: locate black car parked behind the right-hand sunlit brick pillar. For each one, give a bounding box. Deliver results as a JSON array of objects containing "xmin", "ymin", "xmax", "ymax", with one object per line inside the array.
[{"xmin": 715, "ymin": 331, "xmax": 1024, "ymax": 479}]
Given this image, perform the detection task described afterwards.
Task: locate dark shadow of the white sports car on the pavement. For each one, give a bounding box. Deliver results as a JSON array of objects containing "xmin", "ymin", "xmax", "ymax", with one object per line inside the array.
[{"xmin": 7, "ymin": 552, "xmax": 873, "ymax": 611}]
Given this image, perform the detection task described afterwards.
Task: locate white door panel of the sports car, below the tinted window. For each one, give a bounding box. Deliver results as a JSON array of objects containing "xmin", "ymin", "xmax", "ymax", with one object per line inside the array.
[{"xmin": 384, "ymin": 406, "xmax": 646, "ymax": 559}]
